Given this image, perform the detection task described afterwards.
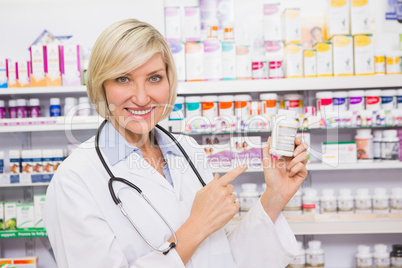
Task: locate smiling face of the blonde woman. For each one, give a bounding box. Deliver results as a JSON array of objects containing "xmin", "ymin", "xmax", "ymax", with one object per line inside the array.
[{"xmin": 104, "ymin": 53, "xmax": 169, "ymax": 145}]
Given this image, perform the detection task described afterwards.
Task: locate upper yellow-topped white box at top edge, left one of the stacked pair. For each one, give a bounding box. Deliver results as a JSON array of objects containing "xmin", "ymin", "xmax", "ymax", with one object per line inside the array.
[{"xmin": 327, "ymin": 0, "xmax": 350, "ymax": 38}]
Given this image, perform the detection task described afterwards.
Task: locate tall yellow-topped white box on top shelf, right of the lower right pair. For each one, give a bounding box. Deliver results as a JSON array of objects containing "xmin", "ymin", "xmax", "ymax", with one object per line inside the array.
[{"xmin": 354, "ymin": 34, "xmax": 374, "ymax": 75}]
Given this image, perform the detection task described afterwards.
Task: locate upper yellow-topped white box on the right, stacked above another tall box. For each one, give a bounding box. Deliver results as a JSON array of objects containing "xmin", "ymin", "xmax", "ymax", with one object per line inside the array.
[{"xmin": 350, "ymin": 0, "xmax": 371, "ymax": 35}]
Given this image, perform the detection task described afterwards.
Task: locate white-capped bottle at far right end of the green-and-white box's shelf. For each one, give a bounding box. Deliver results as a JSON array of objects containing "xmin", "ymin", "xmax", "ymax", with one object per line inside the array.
[{"xmin": 381, "ymin": 129, "xmax": 399, "ymax": 161}]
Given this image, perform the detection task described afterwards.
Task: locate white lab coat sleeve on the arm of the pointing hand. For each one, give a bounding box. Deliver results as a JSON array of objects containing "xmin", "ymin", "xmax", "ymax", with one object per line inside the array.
[{"xmin": 44, "ymin": 166, "xmax": 184, "ymax": 268}]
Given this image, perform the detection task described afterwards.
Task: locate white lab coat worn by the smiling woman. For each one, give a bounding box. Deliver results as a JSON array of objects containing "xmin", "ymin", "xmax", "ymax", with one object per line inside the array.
[{"xmin": 44, "ymin": 126, "xmax": 297, "ymax": 268}]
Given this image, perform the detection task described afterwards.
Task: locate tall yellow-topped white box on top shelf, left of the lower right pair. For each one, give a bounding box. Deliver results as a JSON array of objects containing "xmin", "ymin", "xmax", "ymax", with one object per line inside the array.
[{"xmin": 331, "ymin": 35, "xmax": 354, "ymax": 76}]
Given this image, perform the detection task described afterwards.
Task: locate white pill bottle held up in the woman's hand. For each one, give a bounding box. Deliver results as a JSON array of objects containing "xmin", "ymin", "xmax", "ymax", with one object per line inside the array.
[{"xmin": 269, "ymin": 109, "xmax": 299, "ymax": 159}]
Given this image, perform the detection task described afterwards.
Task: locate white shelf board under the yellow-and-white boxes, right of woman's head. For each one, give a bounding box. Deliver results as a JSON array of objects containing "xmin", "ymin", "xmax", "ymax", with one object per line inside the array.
[{"xmin": 178, "ymin": 75, "xmax": 402, "ymax": 95}]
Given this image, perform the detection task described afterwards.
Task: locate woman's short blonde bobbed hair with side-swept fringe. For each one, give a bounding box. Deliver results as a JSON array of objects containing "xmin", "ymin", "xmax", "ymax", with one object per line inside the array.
[{"xmin": 87, "ymin": 19, "xmax": 177, "ymax": 120}]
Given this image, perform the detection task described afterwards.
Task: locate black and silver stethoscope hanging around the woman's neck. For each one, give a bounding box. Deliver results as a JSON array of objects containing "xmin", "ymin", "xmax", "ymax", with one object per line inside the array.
[{"xmin": 95, "ymin": 120, "xmax": 206, "ymax": 255}]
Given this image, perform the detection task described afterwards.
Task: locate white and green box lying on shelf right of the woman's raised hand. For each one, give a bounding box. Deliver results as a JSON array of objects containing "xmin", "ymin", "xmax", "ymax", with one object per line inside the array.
[{"xmin": 321, "ymin": 141, "xmax": 357, "ymax": 165}]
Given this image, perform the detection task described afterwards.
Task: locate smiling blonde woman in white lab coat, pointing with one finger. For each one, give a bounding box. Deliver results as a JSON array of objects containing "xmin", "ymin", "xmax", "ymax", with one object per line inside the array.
[{"xmin": 44, "ymin": 19, "xmax": 307, "ymax": 268}]
